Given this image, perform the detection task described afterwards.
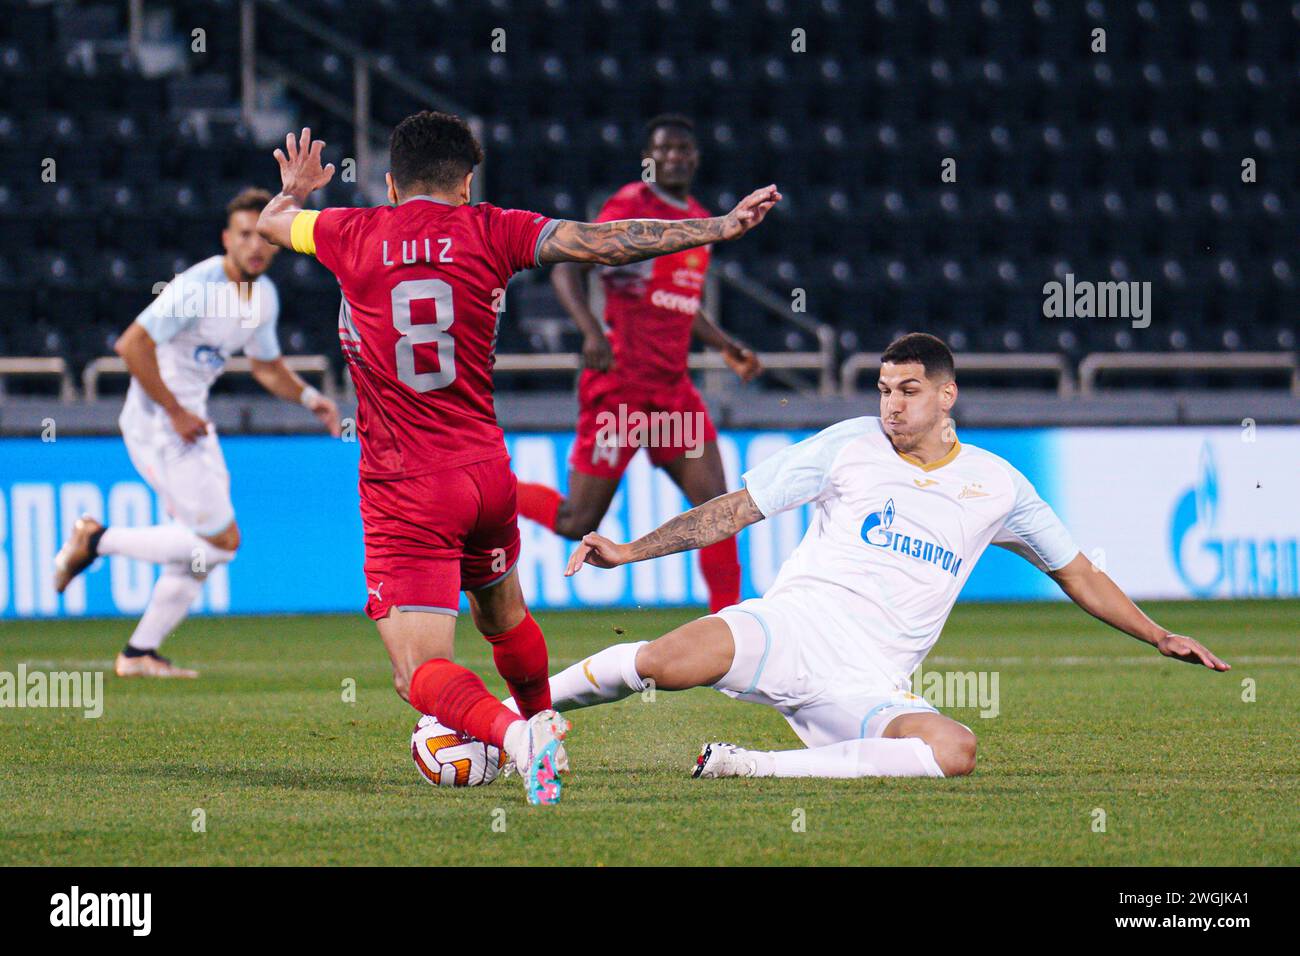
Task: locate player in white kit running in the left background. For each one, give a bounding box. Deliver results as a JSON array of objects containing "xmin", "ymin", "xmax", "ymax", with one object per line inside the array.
[{"xmin": 55, "ymin": 189, "xmax": 339, "ymax": 678}]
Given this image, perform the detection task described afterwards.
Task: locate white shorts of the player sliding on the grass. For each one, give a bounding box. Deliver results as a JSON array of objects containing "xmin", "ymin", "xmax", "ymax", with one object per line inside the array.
[{"xmin": 714, "ymin": 597, "xmax": 939, "ymax": 747}]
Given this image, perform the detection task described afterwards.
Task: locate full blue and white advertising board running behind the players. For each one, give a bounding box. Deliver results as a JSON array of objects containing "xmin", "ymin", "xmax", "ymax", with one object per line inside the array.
[{"xmin": 0, "ymin": 428, "xmax": 1300, "ymax": 618}]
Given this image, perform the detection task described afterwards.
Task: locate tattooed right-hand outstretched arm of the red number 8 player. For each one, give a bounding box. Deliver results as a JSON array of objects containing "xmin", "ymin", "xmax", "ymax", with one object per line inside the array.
[{"xmin": 537, "ymin": 186, "xmax": 781, "ymax": 265}]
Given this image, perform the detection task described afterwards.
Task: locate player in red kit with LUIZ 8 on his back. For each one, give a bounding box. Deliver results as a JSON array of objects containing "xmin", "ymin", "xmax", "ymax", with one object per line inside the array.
[{"xmin": 257, "ymin": 112, "xmax": 780, "ymax": 804}]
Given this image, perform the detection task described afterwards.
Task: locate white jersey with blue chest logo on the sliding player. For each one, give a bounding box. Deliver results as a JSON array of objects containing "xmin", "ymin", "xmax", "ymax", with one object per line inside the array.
[{"xmin": 742, "ymin": 418, "xmax": 1079, "ymax": 684}]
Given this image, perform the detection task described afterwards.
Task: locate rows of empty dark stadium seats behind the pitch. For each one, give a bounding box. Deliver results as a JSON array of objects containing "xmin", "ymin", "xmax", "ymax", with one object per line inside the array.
[{"xmin": 0, "ymin": 0, "xmax": 1300, "ymax": 390}]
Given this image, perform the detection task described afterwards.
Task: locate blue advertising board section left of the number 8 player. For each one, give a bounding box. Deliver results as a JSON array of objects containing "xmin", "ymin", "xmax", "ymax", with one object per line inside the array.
[{"xmin": 0, "ymin": 436, "xmax": 365, "ymax": 618}]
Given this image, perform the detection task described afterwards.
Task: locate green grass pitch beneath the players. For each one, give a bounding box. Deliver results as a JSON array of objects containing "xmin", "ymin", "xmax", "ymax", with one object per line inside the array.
[{"xmin": 0, "ymin": 601, "xmax": 1300, "ymax": 866}]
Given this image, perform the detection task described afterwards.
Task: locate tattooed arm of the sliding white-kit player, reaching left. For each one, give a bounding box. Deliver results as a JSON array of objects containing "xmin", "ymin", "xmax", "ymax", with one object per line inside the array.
[{"xmin": 564, "ymin": 488, "xmax": 763, "ymax": 576}]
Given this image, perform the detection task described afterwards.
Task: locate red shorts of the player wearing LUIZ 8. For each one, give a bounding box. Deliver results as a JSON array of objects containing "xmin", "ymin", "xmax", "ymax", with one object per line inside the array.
[{"xmin": 360, "ymin": 457, "xmax": 519, "ymax": 620}]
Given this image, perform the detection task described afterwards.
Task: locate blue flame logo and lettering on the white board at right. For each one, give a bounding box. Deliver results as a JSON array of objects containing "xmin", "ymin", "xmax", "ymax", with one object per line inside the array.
[{"xmin": 1169, "ymin": 442, "xmax": 1300, "ymax": 597}]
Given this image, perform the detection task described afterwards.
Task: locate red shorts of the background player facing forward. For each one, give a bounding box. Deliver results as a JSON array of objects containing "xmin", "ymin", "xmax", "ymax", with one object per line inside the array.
[{"xmin": 569, "ymin": 369, "xmax": 718, "ymax": 480}]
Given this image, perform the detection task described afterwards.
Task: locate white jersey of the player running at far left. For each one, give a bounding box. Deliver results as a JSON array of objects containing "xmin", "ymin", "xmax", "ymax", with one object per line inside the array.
[{"xmin": 131, "ymin": 255, "xmax": 280, "ymax": 415}]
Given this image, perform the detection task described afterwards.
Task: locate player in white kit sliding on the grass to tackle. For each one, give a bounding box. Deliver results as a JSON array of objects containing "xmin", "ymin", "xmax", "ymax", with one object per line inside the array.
[{"xmin": 530, "ymin": 333, "xmax": 1229, "ymax": 778}]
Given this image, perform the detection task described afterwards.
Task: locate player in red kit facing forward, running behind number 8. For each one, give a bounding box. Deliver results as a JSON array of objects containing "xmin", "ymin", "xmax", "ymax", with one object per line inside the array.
[{"xmin": 519, "ymin": 113, "xmax": 762, "ymax": 611}]
